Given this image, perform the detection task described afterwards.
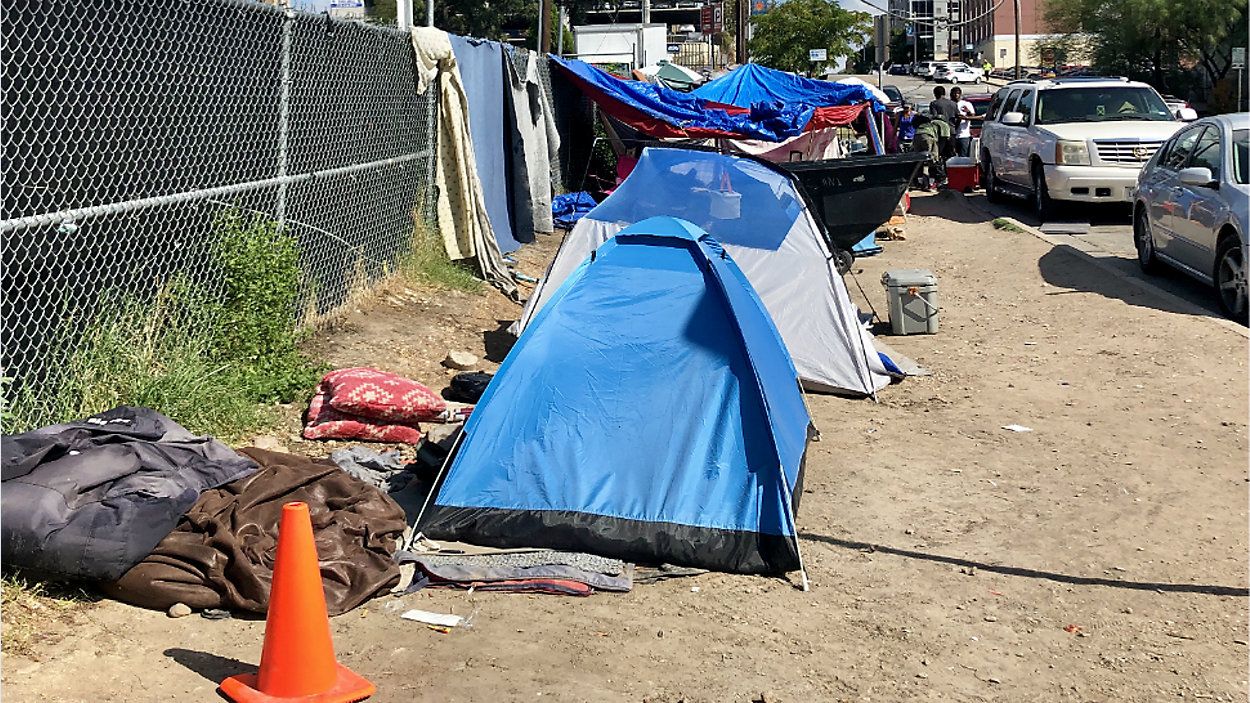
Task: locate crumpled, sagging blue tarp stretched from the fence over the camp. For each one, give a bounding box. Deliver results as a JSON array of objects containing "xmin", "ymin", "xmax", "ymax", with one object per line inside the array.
[{"xmin": 551, "ymin": 55, "xmax": 815, "ymax": 141}]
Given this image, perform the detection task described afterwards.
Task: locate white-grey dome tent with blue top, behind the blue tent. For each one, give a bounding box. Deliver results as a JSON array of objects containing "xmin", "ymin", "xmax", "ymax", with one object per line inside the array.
[{"xmin": 511, "ymin": 146, "xmax": 899, "ymax": 395}]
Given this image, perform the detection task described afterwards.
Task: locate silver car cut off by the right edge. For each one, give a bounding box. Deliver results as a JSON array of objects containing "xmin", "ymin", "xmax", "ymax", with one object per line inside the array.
[{"xmin": 1133, "ymin": 113, "xmax": 1250, "ymax": 321}]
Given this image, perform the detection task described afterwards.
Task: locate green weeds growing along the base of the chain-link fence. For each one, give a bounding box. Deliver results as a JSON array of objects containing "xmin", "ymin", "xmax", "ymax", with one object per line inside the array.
[{"xmin": 0, "ymin": 206, "xmax": 321, "ymax": 439}]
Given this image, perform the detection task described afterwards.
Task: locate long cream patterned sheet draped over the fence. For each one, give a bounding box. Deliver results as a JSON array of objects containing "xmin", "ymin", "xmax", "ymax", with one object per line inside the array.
[{"xmin": 413, "ymin": 26, "xmax": 518, "ymax": 299}]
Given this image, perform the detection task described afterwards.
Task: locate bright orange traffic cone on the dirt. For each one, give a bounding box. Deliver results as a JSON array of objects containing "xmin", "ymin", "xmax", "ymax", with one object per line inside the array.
[{"xmin": 220, "ymin": 503, "xmax": 378, "ymax": 703}]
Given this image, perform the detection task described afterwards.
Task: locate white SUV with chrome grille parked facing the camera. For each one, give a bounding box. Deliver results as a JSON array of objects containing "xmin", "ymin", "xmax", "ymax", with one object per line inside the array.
[{"xmin": 979, "ymin": 78, "xmax": 1196, "ymax": 219}]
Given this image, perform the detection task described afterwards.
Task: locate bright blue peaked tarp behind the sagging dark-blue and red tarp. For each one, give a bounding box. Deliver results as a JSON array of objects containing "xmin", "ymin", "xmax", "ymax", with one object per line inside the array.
[{"xmin": 691, "ymin": 64, "xmax": 884, "ymax": 111}]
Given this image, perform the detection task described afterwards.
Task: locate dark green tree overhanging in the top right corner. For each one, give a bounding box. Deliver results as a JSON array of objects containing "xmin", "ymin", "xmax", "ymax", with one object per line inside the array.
[{"xmin": 1045, "ymin": 0, "xmax": 1246, "ymax": 88}]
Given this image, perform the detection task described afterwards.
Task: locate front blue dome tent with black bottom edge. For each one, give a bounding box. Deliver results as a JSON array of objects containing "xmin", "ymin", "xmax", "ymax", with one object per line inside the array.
[{"xmin": 419, "ymin": 218, "xmax": 810, "ymax": 573}]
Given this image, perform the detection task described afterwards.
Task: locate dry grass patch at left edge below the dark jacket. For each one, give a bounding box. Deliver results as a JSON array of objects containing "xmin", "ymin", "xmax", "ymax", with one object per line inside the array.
[{"xmin": 0, "ymin": 574, "xmax": 95, "ymax": 657}]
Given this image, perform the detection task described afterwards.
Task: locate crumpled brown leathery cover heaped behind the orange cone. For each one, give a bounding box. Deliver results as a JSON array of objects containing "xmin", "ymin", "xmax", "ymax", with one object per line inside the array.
[{"xmin": 104, "ymin": 448, "xmax": 405, "ymax": 615}]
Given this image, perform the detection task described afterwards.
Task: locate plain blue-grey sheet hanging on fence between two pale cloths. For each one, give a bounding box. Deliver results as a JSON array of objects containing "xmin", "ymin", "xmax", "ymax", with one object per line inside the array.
[{"xmin": 449, "ymin": 34, "xmax": 521, "ymax": 254}]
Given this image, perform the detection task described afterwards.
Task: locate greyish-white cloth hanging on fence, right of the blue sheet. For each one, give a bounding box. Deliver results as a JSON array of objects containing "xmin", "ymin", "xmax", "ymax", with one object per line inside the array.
[{"xmin": 504, "ymin": 49, "xmax": 560, "ymax": 239}]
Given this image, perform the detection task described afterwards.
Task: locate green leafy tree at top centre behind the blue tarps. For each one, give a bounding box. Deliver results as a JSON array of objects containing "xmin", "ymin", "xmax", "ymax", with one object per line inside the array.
[{"xmin": 750, "ymin": 0, "xmax": 873, "ymax": 73}]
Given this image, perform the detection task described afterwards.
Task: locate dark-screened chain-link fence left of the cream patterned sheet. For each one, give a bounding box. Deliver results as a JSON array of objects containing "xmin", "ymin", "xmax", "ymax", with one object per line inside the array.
[{"xmin": 0, "ymin": 0, "xmax": 438, "ymax": 420}]
